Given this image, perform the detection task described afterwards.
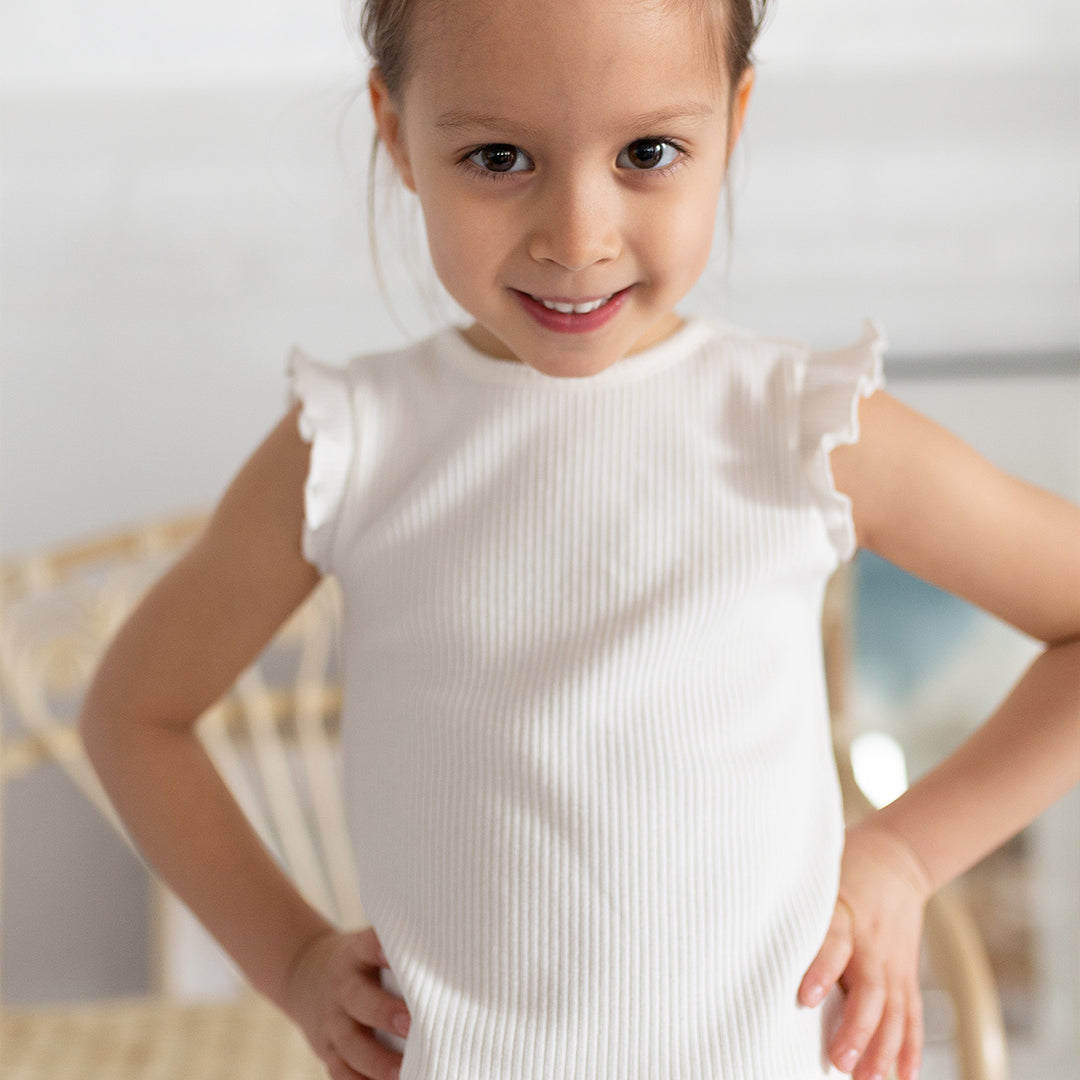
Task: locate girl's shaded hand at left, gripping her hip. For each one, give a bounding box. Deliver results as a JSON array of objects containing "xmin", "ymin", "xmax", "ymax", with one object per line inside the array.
[{"xmin": 284, "ymin": 927, "xmax": 409, "ymax": 1080}]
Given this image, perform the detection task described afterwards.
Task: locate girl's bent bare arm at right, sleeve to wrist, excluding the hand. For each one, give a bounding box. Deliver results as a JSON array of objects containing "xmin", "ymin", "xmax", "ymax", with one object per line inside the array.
[{"xmin": 832, "ymin": 393, "xmax": 1080, "ymax": 891}]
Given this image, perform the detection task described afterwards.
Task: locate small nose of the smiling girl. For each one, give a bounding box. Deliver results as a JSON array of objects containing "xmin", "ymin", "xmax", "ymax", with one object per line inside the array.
[{"xmin": 528, "ymin": 174, "xmax": 621, "ymax": 271}]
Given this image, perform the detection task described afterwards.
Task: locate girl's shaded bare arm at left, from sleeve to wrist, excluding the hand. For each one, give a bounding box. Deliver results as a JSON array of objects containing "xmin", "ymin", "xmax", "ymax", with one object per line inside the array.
[{"xmin": 79, "ymin": 413, "xmax": 330, "ymax": 1003}]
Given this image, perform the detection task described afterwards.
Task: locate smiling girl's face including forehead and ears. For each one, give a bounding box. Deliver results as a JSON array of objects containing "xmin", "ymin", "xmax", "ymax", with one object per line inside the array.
[{"xmin": 372, "ymin": 0, "xmax": 753, "ymax": 376}]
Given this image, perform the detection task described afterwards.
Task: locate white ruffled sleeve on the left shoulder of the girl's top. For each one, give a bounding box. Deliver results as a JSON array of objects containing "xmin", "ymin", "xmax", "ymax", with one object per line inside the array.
[{"xmin": 288, "ymin": 349, "xmax": 355, "ymax": 573}]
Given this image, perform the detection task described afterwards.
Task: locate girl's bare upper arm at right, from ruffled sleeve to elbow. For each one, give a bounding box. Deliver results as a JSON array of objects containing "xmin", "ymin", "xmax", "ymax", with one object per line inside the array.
[{"xmin": 832, "ymin": 391, "xmax": 1080, "ymax": 642}]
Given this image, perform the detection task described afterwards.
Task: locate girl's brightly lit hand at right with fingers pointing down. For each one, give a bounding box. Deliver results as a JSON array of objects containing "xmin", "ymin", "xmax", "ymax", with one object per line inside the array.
[{"xmin": 799, "ymin": 816, "xmax": 931, "ymax": 1080}]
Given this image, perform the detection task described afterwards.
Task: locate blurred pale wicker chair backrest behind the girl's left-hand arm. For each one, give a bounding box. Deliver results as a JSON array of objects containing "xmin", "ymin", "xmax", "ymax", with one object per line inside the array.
[{"xmin": 0, "ymin": 517, "xmax": 365, "ymax": 927}]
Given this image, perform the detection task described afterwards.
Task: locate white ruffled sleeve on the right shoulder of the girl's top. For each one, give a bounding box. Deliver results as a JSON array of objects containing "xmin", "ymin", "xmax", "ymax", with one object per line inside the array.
[{"xmin": 799, "ymin": 320, "xmax": 887, "ymax": 561}]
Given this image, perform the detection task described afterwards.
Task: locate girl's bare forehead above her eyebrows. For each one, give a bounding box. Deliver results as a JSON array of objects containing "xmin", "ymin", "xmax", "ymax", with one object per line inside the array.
[{"xmin": 405, "ymin": 0, "xmax": 726, "ymax": 132}]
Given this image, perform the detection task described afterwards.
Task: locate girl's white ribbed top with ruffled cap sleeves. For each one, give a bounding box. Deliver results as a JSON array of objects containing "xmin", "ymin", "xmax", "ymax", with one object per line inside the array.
[{"xmin": 293, "ymin": 321, "xmax": 880, "ymax": 1080}]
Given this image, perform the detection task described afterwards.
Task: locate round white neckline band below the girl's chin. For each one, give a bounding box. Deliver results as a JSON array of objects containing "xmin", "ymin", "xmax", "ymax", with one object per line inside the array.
[{"xmin": 434, "ymin": 315, "xmax": 713, "ymax": 392}]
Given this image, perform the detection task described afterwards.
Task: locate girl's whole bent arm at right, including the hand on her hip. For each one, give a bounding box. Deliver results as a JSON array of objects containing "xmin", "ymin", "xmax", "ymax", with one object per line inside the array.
[{"xmin": 799, "ymin": 392, "xmax": 1080, "ymax": 1080}]
